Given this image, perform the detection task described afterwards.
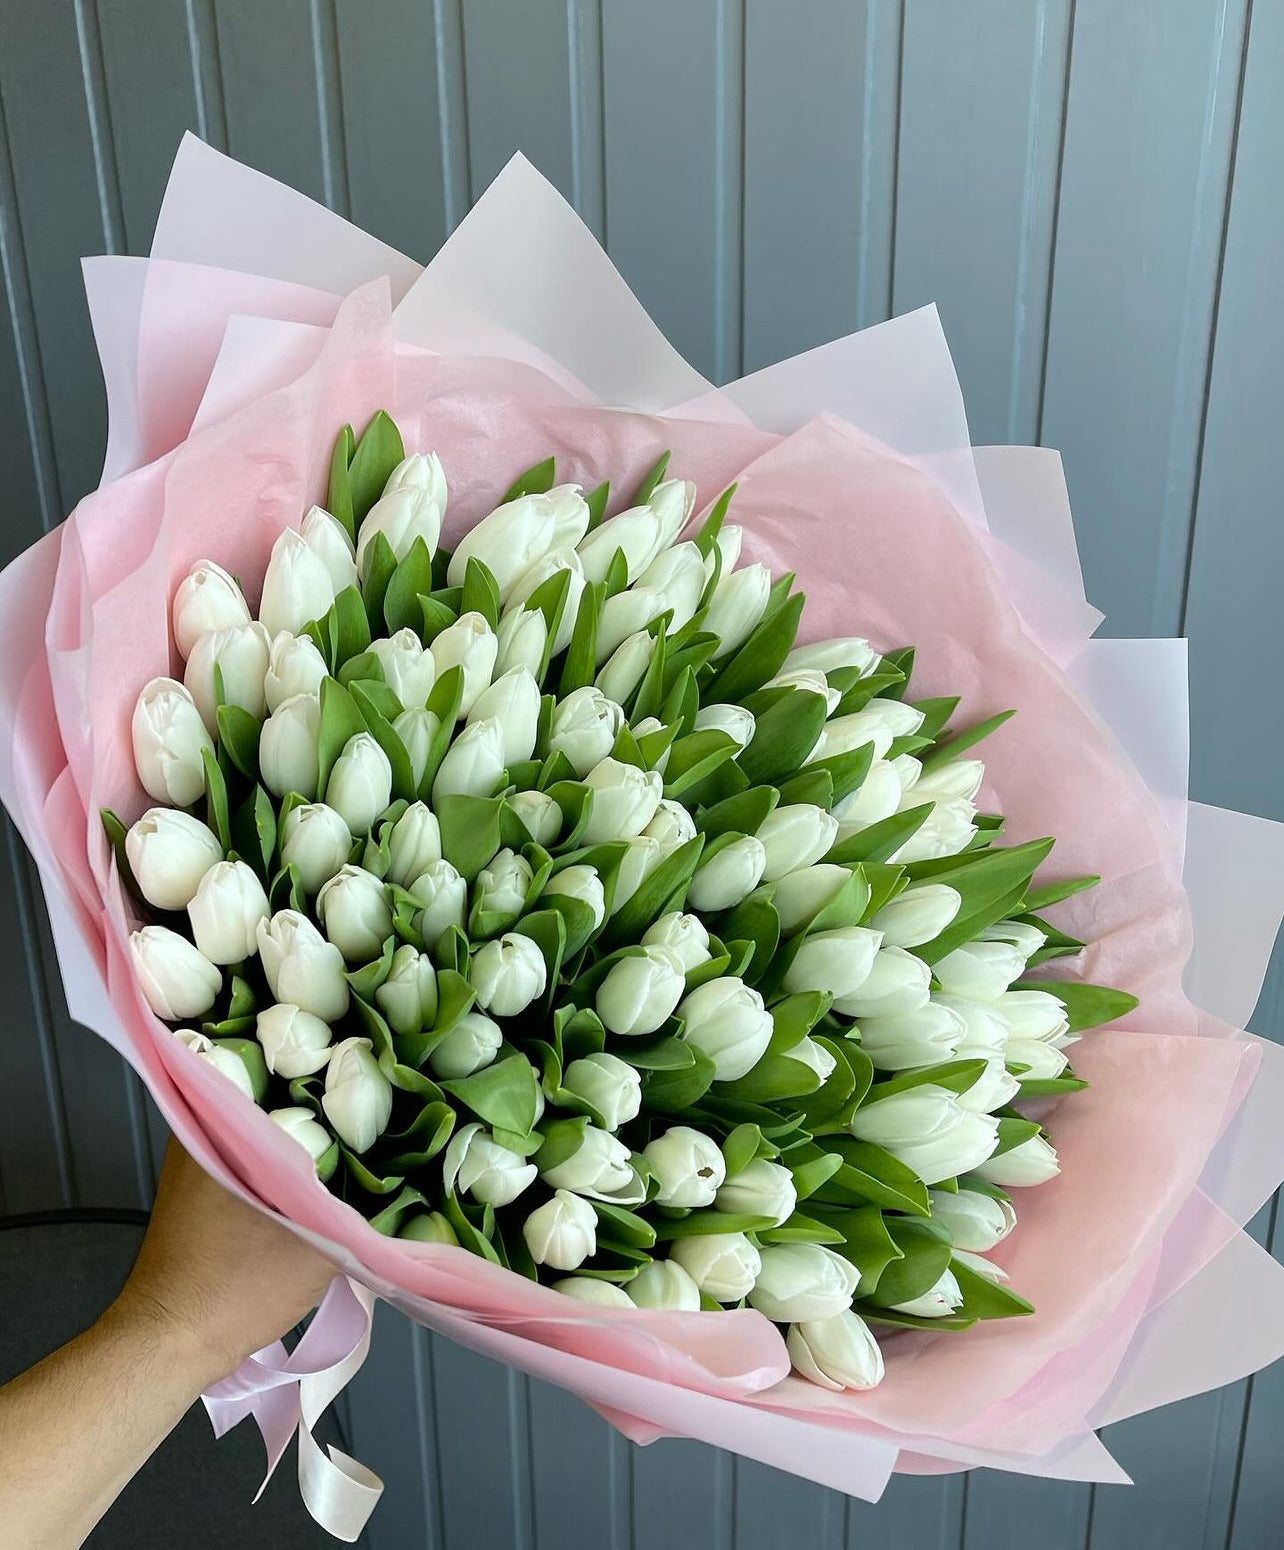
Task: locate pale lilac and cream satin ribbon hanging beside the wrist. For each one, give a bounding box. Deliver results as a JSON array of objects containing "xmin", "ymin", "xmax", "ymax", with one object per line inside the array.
[{"xmin": 202, "ymin": 1276, "xmax": 383, "ymax": 1544}]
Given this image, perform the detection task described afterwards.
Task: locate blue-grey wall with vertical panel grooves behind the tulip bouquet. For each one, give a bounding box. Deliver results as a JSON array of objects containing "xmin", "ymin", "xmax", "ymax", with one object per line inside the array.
[{"xmin": 0, "ymin": 0, "xmax": 1284, "ymax": 1550}]
